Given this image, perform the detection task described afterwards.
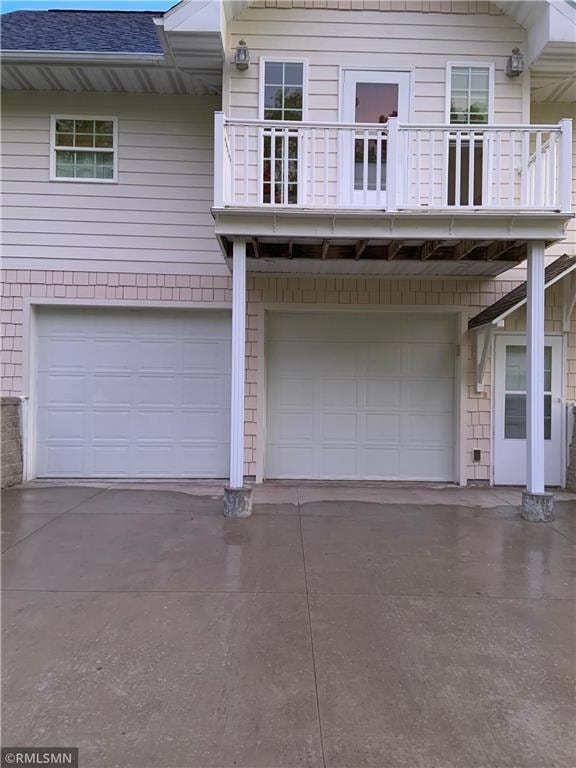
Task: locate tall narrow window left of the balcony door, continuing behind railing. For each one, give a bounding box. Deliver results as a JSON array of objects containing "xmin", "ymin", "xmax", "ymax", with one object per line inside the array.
[{"xmin": 261, "ymin": 59, "xmax": 306, "ymax": 205}]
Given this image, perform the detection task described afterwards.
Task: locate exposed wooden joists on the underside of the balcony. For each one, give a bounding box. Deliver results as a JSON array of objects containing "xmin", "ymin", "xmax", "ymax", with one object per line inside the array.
[{"xmin": 221, "ymin": 238, "xmax": 540, "ymax": 276}]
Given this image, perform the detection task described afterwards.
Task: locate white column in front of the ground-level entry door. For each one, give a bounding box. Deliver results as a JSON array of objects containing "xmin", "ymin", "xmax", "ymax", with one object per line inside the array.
[{"xmin": 526, "ymin": 240, "xmax": 544, "ymax": 493}]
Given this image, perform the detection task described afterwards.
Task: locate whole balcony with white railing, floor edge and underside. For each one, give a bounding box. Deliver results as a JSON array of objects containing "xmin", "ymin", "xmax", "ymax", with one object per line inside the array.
[{"xmin": 213, "ymin": 113, "xmax": 572, "ymax": 274}]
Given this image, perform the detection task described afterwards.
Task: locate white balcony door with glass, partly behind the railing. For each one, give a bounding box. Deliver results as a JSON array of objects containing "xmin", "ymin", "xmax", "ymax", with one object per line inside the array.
[{"xmin": 342, "ymin": 70, "xmax": 410, "ymax": 208}]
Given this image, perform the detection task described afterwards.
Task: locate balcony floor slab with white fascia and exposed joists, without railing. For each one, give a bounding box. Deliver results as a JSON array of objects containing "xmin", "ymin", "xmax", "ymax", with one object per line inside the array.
[{"xmin": 213, "ymin": 207, "xmax": 570, "ymax": 276}]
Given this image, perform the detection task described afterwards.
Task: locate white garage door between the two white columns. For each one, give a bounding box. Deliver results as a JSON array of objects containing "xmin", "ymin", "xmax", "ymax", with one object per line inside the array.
[{"xmin": 266, "ymin": 312, "xmax": 456, "ymax": 480}]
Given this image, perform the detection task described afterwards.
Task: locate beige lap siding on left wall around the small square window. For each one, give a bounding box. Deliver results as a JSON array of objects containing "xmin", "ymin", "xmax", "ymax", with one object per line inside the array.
[{"xmin": 2, "ymin": 93, "xmax": 227, "ymax": 275}]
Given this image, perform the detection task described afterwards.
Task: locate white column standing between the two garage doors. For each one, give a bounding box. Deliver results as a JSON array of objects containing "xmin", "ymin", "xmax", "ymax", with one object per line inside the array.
[{"xmin": 230, "ymin": 239, "xmax": 246, "ymax": 488}]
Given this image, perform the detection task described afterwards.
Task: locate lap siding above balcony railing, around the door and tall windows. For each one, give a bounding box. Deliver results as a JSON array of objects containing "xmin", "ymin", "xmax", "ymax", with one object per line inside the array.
[{"xmin": 225, "ymin": 3, "xmax": 525, "ymax": 123}]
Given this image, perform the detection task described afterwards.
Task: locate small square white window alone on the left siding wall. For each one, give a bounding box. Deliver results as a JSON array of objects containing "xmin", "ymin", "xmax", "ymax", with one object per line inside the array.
[{"xmin": 50, "ymin": 115, "xmax": 118, "ymax": 182}]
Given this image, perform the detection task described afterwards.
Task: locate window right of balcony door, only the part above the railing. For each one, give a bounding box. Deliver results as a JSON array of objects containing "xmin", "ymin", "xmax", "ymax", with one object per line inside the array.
[{"xmin": 447, "ymin": 64, "xmax": 494, "ymax": 124}]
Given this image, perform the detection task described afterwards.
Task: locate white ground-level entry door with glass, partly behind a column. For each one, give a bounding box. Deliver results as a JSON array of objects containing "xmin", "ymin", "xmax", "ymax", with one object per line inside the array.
[{"xmin": 494, "ymin": 336, "xmax": 563, "ymax": 485}]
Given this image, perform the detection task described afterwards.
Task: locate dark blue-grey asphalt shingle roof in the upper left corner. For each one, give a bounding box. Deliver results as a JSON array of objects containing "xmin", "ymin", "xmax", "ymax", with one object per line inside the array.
[{"xmin": 0, "ymin": 11, "xmax": 163, "ymax": 53}]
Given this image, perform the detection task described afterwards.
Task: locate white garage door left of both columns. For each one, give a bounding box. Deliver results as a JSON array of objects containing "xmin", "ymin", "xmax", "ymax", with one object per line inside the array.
[{"xmin": 36, "ymin": 308, "xmax": 230, "ymax": 477}]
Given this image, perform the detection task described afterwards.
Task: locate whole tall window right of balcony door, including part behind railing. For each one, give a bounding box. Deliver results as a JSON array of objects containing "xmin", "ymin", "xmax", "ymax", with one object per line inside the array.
[{"xmin": 447, "ymin": 64, "xmax": 494, "ymax": 206}]
